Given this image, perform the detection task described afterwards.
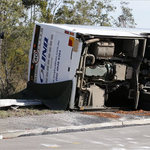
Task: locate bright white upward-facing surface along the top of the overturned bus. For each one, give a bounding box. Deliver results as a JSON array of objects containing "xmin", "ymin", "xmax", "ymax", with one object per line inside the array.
[{"xmin": 39, "ymin": 23, "xmax": 150, "ymax": 37}]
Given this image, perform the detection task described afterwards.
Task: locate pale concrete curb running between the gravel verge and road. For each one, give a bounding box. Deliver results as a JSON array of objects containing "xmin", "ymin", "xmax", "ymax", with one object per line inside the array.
[{"xmin": 0, "ymin": 119, "xmax": 150, "ymax": 140}]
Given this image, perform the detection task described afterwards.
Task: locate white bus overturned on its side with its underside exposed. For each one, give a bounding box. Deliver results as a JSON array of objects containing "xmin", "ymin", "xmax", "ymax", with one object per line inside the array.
[{"xmin": 27, "ymin": 23, "xmax": 150, "ymax": 110}]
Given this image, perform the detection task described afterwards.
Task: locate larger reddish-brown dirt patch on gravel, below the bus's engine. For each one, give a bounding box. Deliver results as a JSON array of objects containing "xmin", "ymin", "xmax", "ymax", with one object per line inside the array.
[{"xmin": 82, "ymin": 112, "xmax": 120, "ymax": 118}]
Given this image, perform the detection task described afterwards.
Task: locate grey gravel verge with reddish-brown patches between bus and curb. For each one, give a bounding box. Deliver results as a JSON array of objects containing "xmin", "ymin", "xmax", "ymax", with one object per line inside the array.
[{"xmin": 0, "ymin": 111, "xmax": 150, "ymax": 133}]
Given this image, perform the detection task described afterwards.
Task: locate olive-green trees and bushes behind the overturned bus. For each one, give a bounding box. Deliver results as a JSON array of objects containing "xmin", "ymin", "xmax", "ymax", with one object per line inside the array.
[{"xmin": 0, "ymin": 0, "xmax": 136, "ymax": 98}]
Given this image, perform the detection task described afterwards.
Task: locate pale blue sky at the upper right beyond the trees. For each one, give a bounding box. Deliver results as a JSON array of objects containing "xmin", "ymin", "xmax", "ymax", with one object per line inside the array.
[{"xmin": 112, "ymin": 0, "xmax": 150, "ymax": 29}]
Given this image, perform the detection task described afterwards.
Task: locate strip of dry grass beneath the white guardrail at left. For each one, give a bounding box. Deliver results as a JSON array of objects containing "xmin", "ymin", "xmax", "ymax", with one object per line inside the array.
[{"xmin": 0, "ymin": 106, "xmax": 64, "ymax": 119}]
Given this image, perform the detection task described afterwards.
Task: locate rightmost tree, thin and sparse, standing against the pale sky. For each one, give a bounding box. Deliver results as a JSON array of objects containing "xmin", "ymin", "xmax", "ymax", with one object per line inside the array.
[{"xmin": 114, "ymin": 1, "xmax": 136, "ymax": 28}]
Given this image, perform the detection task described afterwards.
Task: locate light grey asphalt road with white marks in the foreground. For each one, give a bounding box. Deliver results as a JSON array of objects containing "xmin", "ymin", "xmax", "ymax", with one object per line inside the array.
[{"xmin": 0, "ymin": 125, "xmax": 150, "ymax": 150}]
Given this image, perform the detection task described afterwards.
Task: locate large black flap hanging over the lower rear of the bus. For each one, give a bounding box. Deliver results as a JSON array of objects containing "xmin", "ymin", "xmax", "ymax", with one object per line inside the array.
[{"xmin": 9, "ymin": 80, "xmax": 72, "ymax": 110}]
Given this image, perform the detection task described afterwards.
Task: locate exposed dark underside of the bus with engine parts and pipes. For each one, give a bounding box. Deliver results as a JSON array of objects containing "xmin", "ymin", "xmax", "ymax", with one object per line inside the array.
[{"xmin": 75, "ymin": 34, "xmax": 150, "ymax": 110}]
